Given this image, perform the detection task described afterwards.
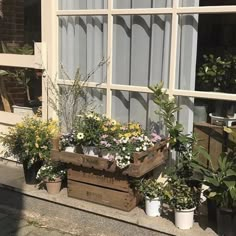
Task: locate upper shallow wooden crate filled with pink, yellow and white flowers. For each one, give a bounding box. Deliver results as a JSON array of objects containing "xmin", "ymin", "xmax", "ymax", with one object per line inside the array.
[{"xmin": 51, "ymin": 141, "xmax": 167, "ymax": 178}]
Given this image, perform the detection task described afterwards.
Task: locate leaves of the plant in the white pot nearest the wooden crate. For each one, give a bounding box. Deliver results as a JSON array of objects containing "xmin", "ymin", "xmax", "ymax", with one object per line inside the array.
[{"xmin": 135, "ymin": 179, "xmax": 164, "ymax": 200}]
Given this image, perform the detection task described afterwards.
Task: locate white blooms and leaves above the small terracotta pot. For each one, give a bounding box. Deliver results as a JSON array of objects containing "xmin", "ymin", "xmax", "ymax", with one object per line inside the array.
[{"xmin": 36, "ymin": 162, "xmax": 66, "ymax": 181}]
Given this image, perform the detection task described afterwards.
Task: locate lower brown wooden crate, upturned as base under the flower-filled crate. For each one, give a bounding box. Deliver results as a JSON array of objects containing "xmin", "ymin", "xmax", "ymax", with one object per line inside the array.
[{"xmin": 67, "ymin": 165, "xmax": 140, "ymax": 211}]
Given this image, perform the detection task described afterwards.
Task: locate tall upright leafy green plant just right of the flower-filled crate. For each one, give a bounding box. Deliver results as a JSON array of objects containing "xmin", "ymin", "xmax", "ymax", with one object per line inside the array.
[{"xmin": 150, "ymin": 83, "xmax": 198, "ymax": 179}]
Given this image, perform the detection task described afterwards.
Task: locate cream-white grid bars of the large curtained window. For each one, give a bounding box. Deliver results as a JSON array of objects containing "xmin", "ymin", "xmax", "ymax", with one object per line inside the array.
[{"xmin": 50, "ymin": 0, "xmax": 236, "ymax": 117}]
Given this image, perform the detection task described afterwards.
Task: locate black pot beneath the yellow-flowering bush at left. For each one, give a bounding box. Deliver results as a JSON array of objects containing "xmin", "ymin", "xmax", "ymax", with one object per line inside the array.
[{"xmin": 23, "ymin": 161, "xmax": 42, "ymax": 185}]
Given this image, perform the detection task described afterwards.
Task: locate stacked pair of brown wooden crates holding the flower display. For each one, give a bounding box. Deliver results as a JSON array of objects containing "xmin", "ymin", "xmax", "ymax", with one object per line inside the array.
[{"xmin": 51, "ymin": 142, "xmax": 167, "ymax": 211}]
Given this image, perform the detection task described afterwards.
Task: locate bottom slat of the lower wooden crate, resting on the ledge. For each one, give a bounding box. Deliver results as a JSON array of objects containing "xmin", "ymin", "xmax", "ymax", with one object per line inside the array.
[{"xmin": 68, "ymin": 180, "xmax": 138, "ymax": 211}]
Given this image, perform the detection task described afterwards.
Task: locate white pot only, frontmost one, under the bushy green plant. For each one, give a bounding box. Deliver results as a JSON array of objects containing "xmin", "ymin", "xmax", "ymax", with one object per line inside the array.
[{"xmin": 175, "ymin": 207, "xmax": 196, "ymax": 229}]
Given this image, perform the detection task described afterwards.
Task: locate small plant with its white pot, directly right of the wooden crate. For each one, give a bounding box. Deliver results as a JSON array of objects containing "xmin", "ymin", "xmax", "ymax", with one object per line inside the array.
[{"xmin": 136, "ymin": 179, "xmax": 163, "ymax": 217}]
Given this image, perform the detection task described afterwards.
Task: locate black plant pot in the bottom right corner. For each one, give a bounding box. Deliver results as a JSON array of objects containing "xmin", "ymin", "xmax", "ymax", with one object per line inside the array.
[{"xmin": 217, "ymin": 208, "xmax": 236, "ymax": 236}]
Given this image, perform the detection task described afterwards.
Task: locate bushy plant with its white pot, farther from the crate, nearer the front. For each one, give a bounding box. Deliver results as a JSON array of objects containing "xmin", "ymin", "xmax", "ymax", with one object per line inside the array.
[{"xmin": 164, "ymin": 180, "xmax": 199, "ymax": 229}]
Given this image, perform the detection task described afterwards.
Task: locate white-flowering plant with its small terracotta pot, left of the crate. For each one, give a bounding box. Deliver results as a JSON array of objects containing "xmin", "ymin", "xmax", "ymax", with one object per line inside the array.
[{"xmin": 37, "ymin": 162, "xmax": 66, "ymax": 194}]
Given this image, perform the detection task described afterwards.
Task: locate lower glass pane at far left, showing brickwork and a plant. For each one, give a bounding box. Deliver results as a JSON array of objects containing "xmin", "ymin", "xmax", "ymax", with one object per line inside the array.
[{"xmin": 0, "ymin": 67, "xmax": 42, "ymax": 115}]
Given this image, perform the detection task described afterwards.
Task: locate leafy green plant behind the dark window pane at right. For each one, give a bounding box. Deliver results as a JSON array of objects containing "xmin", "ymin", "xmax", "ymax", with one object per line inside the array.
[{"xmin": 196, "ymin": 54, "xmax": 236, "ymax": 117}]
